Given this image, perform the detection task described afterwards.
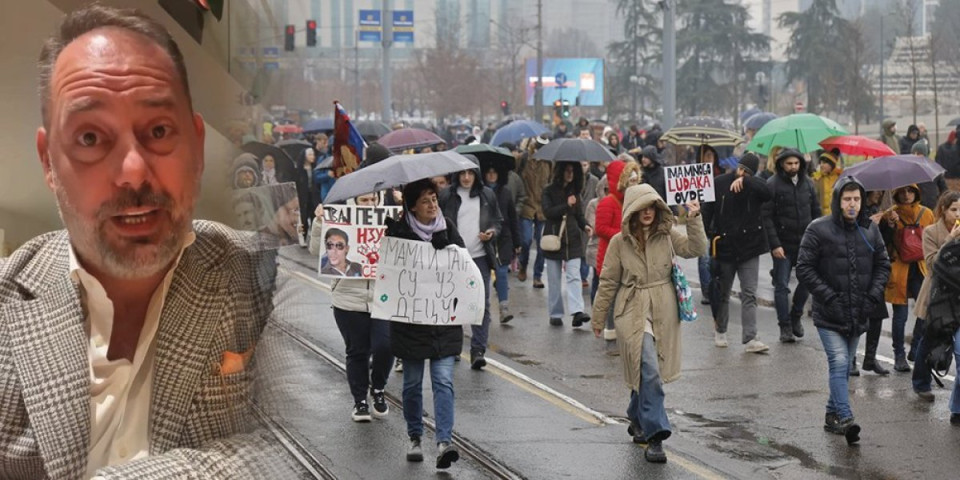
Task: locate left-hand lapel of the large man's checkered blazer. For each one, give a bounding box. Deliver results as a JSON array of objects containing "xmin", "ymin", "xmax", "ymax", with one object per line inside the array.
[{"xmin": 0, "ymin": 233, "xmax": 91, "ymax": 479}]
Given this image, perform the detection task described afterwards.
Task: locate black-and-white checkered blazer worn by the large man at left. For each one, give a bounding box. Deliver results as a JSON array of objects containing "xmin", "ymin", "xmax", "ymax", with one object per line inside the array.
[{"xmin": 0, "ymin": 221, "xmax": 298, "ymax": 479}]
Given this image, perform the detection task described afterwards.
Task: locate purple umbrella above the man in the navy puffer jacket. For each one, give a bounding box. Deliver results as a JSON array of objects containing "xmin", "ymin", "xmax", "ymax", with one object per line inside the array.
[{"xmin": 840, "ymin": 155, "xmax": 945, "ymax": 191}]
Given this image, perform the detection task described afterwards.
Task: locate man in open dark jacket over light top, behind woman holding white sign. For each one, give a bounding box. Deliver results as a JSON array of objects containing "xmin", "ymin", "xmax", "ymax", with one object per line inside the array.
[{"xmin": 440, "ymin": 154, "xmax": 503, "ymax": 370}]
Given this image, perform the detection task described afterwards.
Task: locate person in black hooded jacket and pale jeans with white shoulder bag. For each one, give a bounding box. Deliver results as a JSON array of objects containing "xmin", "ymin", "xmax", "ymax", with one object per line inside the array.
[{"xmin": 541, "ymin": 162, "xmax": 592, "ymax": 327}]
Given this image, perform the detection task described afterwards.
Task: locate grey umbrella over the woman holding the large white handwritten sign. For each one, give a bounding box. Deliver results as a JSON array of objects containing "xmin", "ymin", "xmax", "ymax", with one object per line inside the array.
[{"xmin": 324, "ymin": 150, "xmax": 477, "ymax": 203}]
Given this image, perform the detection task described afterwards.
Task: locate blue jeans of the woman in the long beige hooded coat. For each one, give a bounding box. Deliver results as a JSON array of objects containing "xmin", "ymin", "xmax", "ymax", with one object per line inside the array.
[{"xmin": 627, "ymin": 333, "xmax": 671, "ymax": 440}]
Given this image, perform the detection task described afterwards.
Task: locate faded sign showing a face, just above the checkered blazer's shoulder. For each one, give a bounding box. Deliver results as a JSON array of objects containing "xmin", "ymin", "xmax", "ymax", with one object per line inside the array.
[{"xmin": 233, "ymin": 182, "xmax": 301, "ymax": 249}]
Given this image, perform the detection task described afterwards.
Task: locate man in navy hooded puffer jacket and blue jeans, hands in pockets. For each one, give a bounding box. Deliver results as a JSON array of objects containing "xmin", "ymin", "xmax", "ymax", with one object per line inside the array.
[{"xmin": 797, "ymin": 177, "xmax": 890, "ymax": 444}]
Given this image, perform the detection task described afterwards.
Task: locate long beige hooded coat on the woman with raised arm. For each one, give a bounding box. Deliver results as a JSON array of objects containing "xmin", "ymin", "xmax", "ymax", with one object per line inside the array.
[{"xmin": 591, "ymin": 185, "xmax": 707, "ymax": 391}]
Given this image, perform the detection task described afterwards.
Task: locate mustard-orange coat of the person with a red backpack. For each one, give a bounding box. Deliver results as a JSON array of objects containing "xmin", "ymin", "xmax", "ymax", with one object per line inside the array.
[{"xmin": 880, "ymin": 185, "xmax": 935, "ymax": 305}]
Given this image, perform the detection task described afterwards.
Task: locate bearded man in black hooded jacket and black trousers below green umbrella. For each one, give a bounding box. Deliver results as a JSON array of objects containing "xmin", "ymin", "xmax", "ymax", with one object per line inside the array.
[{"xmin": 763, "ymin": 148, "xmax": 820, "ymax": 343}]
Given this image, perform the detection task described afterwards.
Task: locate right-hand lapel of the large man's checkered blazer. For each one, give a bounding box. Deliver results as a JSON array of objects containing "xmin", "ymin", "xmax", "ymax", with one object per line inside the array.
[{"xmin": 150, "ymin": 244, "xmax": 227, "ymax": 455}]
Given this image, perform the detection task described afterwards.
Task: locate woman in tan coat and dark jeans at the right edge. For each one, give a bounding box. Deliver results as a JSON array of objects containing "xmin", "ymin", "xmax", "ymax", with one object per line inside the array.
[{"xmin": 913, "ymin": 190, "xmax": 960, "ymax": 404}]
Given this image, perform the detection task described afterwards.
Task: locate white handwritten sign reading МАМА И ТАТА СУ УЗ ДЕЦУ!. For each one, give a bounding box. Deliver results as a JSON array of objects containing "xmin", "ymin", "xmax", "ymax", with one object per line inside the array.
[{"xmin": 370, "ymin": 237, "xmax": 484, "ymax": 325}]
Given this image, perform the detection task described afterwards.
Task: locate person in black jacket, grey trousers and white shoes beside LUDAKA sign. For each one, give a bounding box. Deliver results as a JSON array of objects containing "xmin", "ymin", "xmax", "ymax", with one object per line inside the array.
[{"xmin": 703, "ymin": 153, "xmax": 770, "ymax": 353}]
